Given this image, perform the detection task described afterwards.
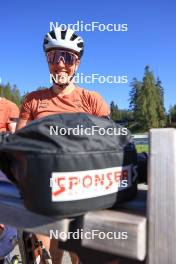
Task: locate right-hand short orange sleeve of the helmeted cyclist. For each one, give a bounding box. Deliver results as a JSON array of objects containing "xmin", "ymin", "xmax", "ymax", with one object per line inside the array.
[{"xmin": 91, "ymin": 92, "xmax": 110, "ymax": 116}]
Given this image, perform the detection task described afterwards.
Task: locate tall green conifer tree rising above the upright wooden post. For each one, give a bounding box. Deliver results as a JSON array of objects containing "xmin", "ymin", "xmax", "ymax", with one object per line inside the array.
[{"xmin": 130, "ymin": 66, "xmax": 166, "ymax": 131}]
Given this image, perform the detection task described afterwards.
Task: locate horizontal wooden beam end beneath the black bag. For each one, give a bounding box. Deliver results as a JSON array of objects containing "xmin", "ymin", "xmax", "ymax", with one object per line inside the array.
[{"xmin": 82, "ymin": 210, "xmax": 146, "ymax": 260}]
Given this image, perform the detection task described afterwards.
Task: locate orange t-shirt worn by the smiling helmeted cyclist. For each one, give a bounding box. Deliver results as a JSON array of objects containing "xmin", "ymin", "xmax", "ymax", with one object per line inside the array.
[{"xmin": 20, "ymin": 87, "xmax": 110, "ymax": 121}]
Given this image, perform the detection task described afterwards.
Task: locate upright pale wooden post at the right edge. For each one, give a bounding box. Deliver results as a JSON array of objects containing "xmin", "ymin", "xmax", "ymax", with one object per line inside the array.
[{"xmin": 148, "ymin": 128, "xmax": 176, "ymax": 264}]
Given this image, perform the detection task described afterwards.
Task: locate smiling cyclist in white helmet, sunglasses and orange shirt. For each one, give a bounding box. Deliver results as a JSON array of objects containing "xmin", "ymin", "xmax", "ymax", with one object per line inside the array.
[{"xmin": 17, "ymin": 27, "xmax": 110, "ymax": 264}]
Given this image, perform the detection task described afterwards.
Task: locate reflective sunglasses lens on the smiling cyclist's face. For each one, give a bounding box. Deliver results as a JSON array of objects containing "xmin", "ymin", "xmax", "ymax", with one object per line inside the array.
[{"xmin": 47, "ymin": 50, "xmax": 76, "ymax": 65}]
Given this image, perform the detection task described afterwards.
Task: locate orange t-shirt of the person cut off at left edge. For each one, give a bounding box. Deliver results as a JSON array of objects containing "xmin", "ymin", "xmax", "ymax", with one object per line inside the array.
[{"xmin": 0, "ymin": 98, "xmax": 19, "ymax": 132}]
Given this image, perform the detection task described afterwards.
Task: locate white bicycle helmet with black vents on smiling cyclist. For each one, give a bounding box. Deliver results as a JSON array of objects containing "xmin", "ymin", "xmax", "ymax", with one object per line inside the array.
[{"xmin": 43, "ymin": 27, "xmax": 84, "ymax": 58}]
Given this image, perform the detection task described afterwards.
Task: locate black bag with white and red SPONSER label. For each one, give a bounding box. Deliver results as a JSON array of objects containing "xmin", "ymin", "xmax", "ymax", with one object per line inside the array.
[{"xmin": 0, "ymin": 113, "xmax": 137, "ymax": 218}]
